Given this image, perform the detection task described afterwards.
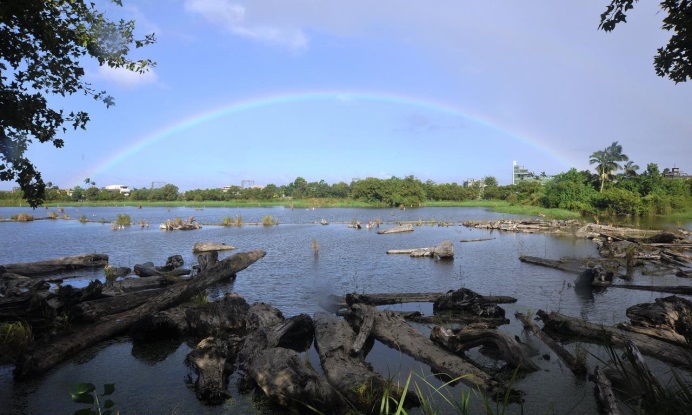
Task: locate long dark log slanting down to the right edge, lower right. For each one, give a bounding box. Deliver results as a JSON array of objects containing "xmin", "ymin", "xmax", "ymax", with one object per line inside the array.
[{"xmin": 536, "ymin": 310, "xmax": 692, "ymax": 370}]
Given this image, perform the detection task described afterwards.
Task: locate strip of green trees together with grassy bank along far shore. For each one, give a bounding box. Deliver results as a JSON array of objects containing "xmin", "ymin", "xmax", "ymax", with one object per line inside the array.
[{"xmin": 0, "ymin": 145, "xmax": 692, "ymax": 221}]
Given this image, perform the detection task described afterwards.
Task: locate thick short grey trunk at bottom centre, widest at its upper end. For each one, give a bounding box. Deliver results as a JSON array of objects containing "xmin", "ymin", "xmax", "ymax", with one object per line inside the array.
[{"xmin": 315, "ymin": 313, "xmax": 419, "ymax": 414}]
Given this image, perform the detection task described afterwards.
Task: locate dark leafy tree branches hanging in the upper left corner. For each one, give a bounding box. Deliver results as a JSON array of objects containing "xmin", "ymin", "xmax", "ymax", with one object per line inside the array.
[{"xmin": 0, "ymin": 0, "xmax": 155, "ymax": 207}]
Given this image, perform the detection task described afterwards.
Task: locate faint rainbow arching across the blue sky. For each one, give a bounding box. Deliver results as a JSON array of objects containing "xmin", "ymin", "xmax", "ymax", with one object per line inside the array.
[{"xmin": 73, "ymin": 90, "xmax": 570, "ymax": 182}]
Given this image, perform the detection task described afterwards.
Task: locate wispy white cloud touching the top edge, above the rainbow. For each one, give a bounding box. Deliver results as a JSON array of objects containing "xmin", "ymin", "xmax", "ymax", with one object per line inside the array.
[{"xmin": 185, "ymin": 0, "xmax": 308, "ymax": 50}]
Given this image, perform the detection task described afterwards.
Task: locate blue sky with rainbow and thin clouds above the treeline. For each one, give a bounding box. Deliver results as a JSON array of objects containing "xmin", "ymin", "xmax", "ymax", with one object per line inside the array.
[{"xmin": 10, "ymin": 0, "xmax": 692, "ymax": 190}]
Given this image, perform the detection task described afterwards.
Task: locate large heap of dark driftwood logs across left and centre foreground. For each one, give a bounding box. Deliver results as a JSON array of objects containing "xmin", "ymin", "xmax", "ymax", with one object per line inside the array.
[{"xmin": 0, "ymin": 251, "xmax": 537, "ymax": 413}]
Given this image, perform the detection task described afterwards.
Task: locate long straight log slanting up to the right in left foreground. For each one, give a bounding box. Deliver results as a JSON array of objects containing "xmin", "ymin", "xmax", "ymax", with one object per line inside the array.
[{"xmin": 14, "ymin": 250, "xmax": 266, "ymax": 378}]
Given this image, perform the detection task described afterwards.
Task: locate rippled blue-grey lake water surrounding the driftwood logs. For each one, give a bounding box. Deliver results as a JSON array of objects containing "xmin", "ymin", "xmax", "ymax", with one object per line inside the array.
[{"xmin": 0, "ymin": 207, "xmax": 692, "ymax": 414}]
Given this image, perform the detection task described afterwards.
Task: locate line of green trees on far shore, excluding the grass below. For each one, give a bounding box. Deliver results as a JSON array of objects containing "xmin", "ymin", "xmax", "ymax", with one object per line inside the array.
[{"xmin": 0, "ymin": 141, "xmax": 692, "ymax": 216}]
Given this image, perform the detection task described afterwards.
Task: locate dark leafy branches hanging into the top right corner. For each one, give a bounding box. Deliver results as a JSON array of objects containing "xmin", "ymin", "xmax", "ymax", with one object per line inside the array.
[{"xmin": 598, "ymin": 0, "xmax": 692, "ymax": 84}]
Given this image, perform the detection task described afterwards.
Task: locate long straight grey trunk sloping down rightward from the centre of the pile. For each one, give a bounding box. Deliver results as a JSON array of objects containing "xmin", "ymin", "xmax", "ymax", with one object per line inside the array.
[{"xmin": 351, "ymin": 304, "xmax": 504, "ymax": 402}]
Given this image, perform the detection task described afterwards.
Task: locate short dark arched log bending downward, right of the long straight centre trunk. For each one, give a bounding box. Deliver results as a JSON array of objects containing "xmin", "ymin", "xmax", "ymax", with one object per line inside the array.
[{"xmin": 430, "ymin": 326, "xmax": 539, "ymax": 372}]
